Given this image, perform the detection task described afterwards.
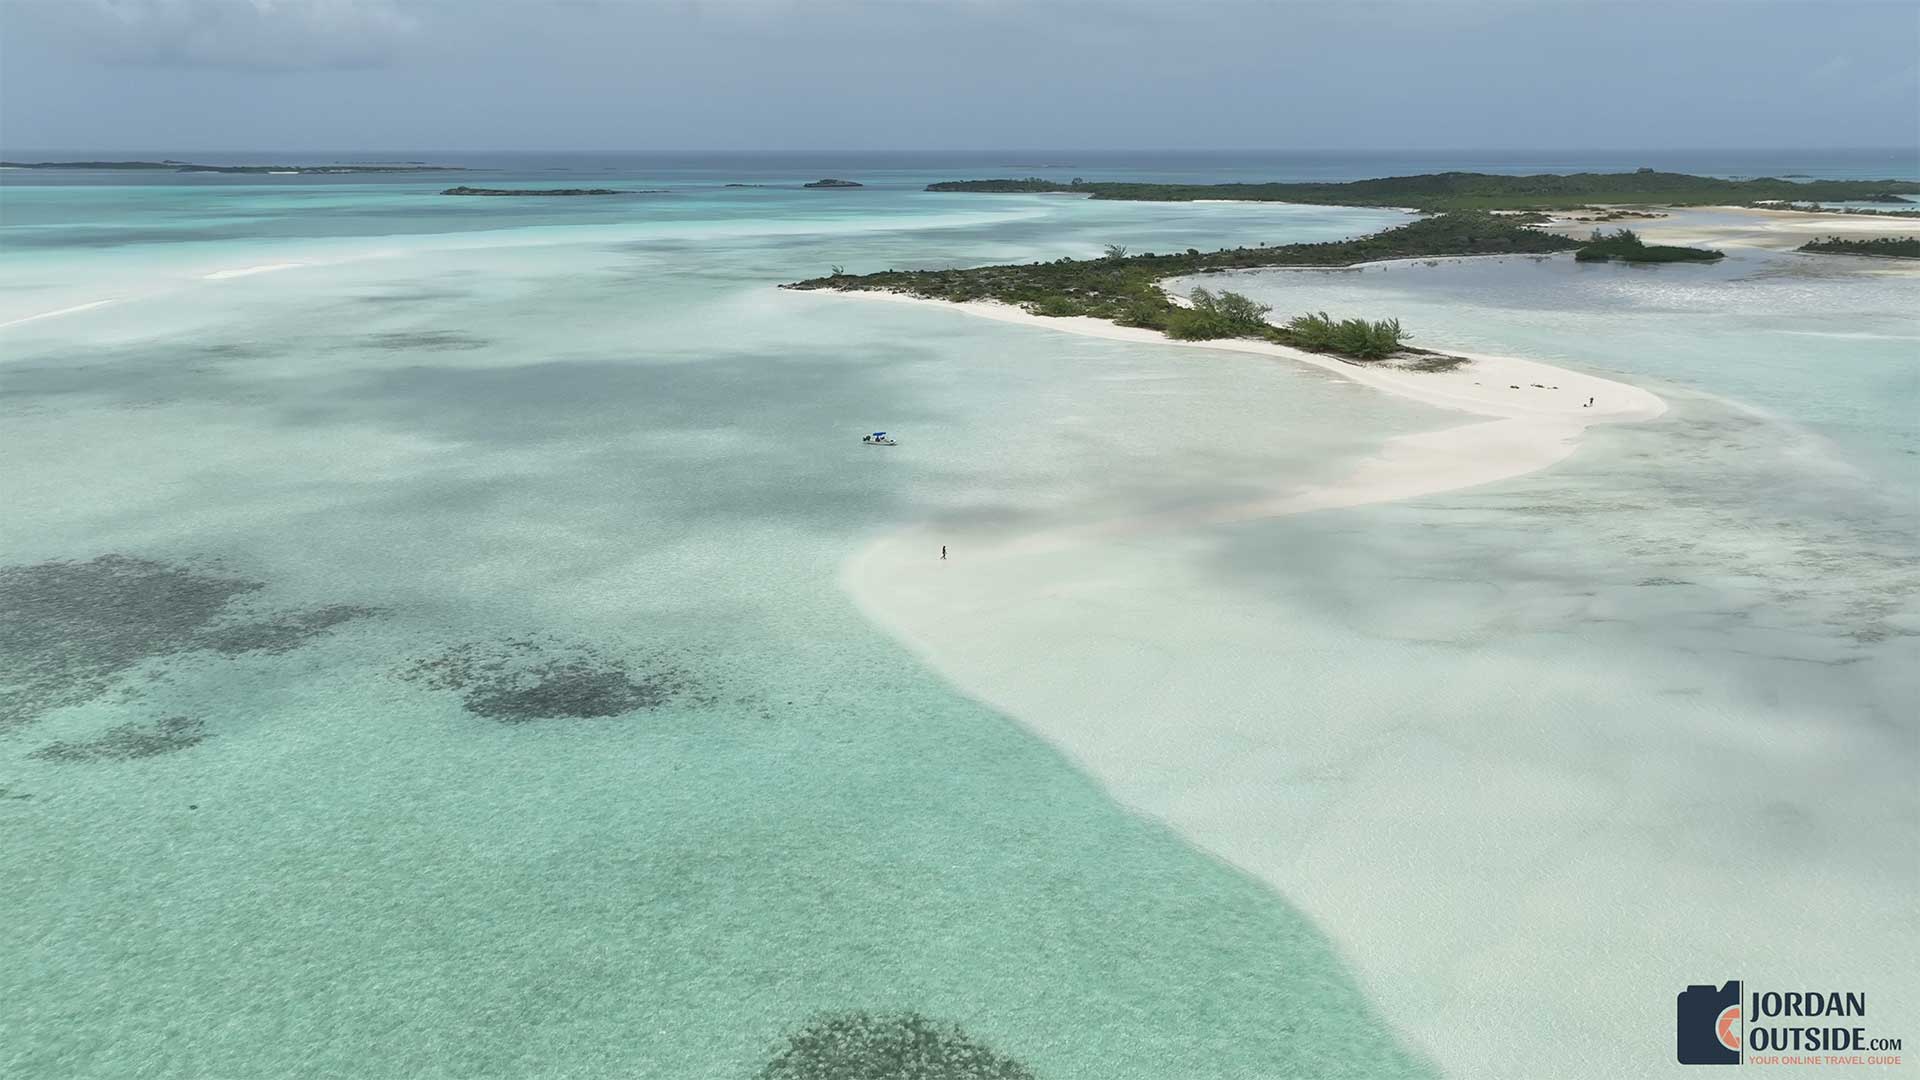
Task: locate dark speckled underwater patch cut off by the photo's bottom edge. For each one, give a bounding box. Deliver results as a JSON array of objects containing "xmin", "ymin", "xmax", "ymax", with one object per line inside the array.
[{"xmin": 760, "ymin": 1011, "xmax": 1035, "ymax": 1080}]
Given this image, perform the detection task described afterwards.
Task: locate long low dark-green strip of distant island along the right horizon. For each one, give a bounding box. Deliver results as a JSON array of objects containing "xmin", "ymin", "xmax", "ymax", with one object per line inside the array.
[{"xmin": 927, "ymin": 169, "xmax": 1920, "ymax": 211}]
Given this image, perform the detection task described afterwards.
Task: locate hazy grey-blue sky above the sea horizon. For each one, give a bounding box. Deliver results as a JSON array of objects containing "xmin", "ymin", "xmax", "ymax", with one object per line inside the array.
[{"xmin": 0, "ymin": 0, "xmax": 1920, "ymax": 152}]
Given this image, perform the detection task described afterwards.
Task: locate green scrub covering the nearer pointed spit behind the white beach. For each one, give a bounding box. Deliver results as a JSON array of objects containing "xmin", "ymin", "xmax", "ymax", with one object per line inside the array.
[{"xmin": 785, "ymin": 211, "xmax": 1580, "ymax": 359}]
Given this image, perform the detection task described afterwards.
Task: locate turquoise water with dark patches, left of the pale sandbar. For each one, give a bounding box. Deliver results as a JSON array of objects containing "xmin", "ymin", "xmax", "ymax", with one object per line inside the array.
[{"xmin": 0, "ymin": 155, "xmax": 1427, "ymax": 1078}]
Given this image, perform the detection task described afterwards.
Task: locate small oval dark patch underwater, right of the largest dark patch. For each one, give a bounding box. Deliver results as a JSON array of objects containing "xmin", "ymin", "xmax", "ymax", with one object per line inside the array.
[{"xmin": 401, "ymin": 640, "xmax": 691, "ymax": 723}]
